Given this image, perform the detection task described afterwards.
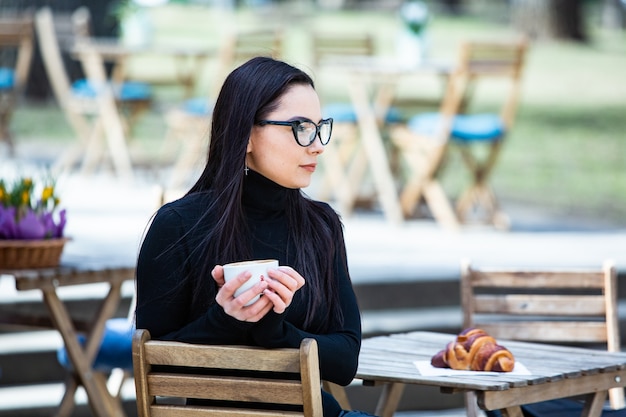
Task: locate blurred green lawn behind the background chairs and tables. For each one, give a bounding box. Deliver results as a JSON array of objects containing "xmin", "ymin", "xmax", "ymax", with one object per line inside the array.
[{"xmin": 13, "ymin": 5, "xmax": 626, "ymax": 224}]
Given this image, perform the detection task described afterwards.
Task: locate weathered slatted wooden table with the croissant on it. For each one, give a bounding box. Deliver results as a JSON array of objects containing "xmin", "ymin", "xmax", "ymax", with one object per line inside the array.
[{"xmin": 356, "ymin": 332, "xmax": 626, "ymax": 417}]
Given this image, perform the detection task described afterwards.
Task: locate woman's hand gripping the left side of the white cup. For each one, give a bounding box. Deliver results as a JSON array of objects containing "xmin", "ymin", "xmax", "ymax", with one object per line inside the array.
[{"xmin": 211, "ymin": 265, "xmax": 275, "ymax": 322}]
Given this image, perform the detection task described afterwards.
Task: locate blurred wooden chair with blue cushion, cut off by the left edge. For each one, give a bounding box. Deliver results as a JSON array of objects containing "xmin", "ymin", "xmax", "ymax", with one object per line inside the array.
[{"xmin": 0, "ymin": 13, "xmax": 34, "ymax": 154}]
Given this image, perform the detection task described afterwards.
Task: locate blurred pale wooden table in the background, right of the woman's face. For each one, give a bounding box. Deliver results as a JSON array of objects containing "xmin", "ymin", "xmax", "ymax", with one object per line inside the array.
[{"xmin": 325, "ymin": 57, "xmax": 450, "ymax": 225}]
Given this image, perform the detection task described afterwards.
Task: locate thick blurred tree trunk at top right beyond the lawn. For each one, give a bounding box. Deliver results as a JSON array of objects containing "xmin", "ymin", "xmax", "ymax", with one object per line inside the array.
[{"xmin": 511, "ymin": 0, "xmax": 587, "ymax": 42}]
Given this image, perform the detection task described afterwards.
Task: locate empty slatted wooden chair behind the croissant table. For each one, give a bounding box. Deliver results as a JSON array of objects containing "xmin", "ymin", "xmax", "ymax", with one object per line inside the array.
[{"xmin": 461, "ymin": 260, "xmax": 624, "ymax": 416}]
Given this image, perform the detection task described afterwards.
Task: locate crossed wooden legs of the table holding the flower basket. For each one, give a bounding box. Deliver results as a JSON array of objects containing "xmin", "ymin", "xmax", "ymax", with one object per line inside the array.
[{"xmin": 43, "ymin": 283, "xmax": 124, "ymax": 417}]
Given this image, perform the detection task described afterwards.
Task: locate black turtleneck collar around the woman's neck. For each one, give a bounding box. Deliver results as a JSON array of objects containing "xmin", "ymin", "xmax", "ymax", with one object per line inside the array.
[{"xmin": 242, "ymin": 169, "xmax": 292, "ymax": 213}]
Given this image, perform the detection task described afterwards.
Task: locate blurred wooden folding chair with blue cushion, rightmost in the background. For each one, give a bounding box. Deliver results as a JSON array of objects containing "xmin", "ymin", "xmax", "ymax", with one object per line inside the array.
[{"xmin": 392, "ymin": 39, "xmax": 527, "ymax": 229}]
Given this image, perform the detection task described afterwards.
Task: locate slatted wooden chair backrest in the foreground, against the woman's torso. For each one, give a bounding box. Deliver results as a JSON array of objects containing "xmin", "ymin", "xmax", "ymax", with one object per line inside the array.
[{"xmin": 133, "ymin": 329, "xmax": 322, "ymax": 417}]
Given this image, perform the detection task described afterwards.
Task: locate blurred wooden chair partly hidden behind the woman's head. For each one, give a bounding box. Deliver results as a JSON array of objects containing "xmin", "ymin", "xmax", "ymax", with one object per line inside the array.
[{"xmin": 162, "ymin": 28, "xmax": 283, "ymax": 188}]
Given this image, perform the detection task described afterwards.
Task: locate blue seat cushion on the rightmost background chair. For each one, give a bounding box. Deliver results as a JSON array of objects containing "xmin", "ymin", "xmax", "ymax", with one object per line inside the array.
[{"xmin": 407, "ymin": 113, "xmax": 505, "ymax": 142}]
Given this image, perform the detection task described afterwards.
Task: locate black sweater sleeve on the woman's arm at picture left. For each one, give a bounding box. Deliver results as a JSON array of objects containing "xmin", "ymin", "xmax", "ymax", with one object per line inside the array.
[{"xmin": 136, "ymin": 206, "xmax": 250, "ymax": 344}]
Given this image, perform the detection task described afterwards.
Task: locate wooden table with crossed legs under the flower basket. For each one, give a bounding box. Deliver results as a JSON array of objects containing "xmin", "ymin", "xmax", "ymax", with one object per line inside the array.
[{"xmin": 0, "ymin": 264, "xmax": 135, "ymax": 417}]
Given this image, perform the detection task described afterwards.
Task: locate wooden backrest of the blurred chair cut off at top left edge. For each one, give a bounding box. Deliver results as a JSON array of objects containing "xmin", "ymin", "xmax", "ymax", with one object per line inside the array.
[{"xmin": 0, "ymin": 13, "xmax": 34, "ymax": 93}]
